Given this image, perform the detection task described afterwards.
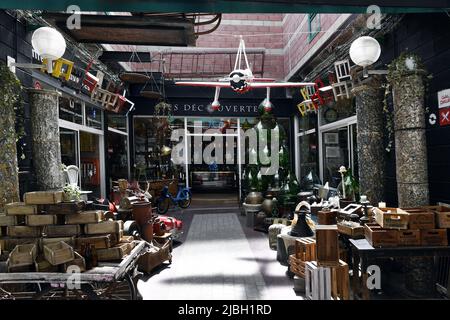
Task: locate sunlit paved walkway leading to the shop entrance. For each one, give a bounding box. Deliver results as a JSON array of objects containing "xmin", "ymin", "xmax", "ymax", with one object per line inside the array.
[{"xmin": 138, "ymin": 207, "xmax": 301, "ymax": 300}]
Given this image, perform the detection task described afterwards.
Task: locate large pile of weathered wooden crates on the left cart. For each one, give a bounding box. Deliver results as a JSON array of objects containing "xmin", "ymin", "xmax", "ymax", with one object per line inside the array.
[{"xmin": 0, "ymin": 191, "xmax": 134, "ymax": 272}]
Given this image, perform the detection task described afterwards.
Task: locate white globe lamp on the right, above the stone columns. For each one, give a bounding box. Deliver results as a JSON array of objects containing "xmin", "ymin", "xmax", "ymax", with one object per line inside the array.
[{"xmin": 350, "ymin": 36, "xmax": 381, "ymax": 68}]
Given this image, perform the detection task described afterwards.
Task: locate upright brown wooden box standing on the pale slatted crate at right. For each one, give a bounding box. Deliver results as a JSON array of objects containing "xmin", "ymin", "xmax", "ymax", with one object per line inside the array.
[{"xmin": 316, "ymin": 225, "xmax": 339, "ymax": 267}]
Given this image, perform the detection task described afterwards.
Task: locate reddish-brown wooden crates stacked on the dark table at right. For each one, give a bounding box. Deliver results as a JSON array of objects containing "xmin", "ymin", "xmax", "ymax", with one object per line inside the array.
[{"xmin": 364, "ymin": 206, "xmax": 450, "ymax": 247}]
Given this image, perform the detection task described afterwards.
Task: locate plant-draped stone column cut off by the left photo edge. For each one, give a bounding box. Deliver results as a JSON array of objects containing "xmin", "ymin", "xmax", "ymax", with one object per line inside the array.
[{"xmin": 0, "ymin": 65, "xmax": 21, "ymax": 212}]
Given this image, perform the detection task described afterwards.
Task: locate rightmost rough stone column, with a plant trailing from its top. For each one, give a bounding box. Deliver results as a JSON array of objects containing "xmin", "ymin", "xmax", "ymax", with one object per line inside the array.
[{"xmin": 388, "ymin": 54, "xmax": 429, "ymax": 207}]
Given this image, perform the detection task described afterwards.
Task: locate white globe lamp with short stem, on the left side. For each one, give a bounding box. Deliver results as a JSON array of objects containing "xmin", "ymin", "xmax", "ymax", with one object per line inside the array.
[{"xmin": 31, "ymin": 27, "xmax": 66, "ymax": 73}]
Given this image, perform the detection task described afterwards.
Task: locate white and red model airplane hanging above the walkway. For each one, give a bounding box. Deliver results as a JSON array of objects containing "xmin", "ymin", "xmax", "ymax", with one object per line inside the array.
[{"xmin": 175, "ymin": 36, "xmax": 315, "ymax": 112}]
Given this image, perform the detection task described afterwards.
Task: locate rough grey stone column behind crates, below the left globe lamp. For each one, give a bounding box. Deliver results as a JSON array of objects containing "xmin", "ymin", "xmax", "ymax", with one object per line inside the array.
[{"xmin": 28, "ymin": 89, "xmax": 64, "ymax": 190}]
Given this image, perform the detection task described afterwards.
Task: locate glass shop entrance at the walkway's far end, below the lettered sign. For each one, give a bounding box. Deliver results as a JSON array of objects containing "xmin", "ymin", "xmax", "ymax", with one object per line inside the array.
[{"xmin": 185, "ymin": 117, "xmax": 241, "ymax": 199}]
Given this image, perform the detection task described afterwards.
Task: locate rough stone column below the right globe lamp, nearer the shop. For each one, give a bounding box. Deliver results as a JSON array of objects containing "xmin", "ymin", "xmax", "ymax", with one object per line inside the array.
[{"xmin": 352, "ymin": 76, "xmax": 385, "ymax": 205}]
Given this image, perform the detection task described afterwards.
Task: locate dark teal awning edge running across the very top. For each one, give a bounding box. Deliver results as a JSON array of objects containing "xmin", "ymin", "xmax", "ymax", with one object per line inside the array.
[{"xmin": 0, "ymin": 0, "xmax": 450, "ymax": 13}]
